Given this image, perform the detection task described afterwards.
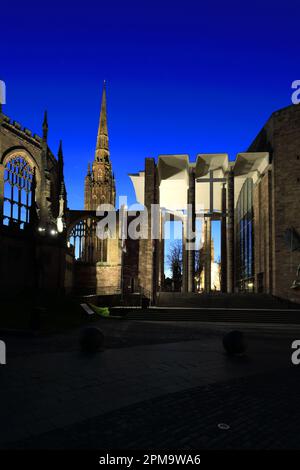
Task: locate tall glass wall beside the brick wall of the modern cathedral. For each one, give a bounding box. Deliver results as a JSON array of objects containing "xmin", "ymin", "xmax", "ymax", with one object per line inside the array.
[{"xmin": 235, "ymin": 178, "xmax": 254, "ymax": 292}]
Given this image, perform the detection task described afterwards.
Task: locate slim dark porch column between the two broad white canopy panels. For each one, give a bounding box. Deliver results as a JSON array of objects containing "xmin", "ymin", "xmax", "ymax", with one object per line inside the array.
[{"xmin": 187, "ymin": 169, "xmax": 196, "ymax": 292}]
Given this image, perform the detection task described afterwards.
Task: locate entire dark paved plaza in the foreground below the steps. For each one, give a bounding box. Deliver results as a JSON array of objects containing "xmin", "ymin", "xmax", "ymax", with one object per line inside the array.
[{"xmin": 0, "ymin": 319, "xmax": 300, "ymax": 449}]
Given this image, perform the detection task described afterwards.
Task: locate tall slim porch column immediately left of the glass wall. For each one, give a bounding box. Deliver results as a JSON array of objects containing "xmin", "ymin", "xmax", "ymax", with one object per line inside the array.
[{"xmin": 227, "ymin": 169, "xmax": 234, "ymax": 294}]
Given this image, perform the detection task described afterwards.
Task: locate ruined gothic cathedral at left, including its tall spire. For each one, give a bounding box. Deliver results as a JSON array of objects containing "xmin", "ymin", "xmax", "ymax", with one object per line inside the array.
[{"xmin": 0, "ymin": 82, "xmax": 121, "ymax": 293}]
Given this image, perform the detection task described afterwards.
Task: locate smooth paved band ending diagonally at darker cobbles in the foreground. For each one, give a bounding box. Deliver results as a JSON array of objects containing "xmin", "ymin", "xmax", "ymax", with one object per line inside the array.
[{"xmin": 0, "ymin": 327, "xmax": 291, "ymax": 447}]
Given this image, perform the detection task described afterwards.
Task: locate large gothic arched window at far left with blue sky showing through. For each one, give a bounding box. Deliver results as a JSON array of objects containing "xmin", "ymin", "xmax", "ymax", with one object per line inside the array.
[{"xmin": 3, "ymin": 156, "xmax": 34, "ymax": 228}]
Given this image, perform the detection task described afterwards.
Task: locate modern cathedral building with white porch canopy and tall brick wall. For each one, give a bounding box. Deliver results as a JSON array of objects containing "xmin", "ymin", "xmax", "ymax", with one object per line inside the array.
[{"xmin": 131, "ymin": 105, "xmax": 300, "ymax": 302}]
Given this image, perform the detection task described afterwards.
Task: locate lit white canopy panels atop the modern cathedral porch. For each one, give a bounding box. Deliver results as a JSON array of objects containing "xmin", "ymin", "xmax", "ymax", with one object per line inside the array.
[{"xmin": 129, "ymin": 152, "xmax": 269, "ymax": 215}]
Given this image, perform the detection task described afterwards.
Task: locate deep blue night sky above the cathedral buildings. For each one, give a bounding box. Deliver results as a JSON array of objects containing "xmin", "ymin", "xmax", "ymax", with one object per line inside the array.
[{"xmin": 0, "ymin": 0, "xmax": 300, "ymax": 208}]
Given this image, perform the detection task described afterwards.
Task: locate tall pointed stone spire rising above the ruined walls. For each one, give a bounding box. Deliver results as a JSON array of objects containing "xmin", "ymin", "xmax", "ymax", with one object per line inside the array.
[{"xmin": 84, "ymin": 82, "xmax": 116, "ymax": 210}]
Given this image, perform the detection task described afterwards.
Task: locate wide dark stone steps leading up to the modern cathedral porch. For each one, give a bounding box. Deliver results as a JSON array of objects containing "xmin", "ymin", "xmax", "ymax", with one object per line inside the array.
[{"xmin": 111, "ymin": 292, "xmax": 300, "ymax": 324}]
